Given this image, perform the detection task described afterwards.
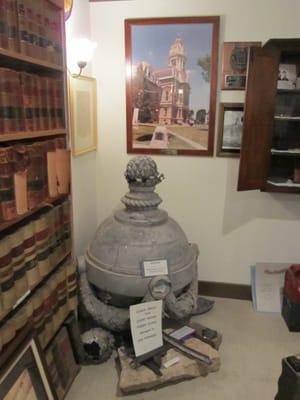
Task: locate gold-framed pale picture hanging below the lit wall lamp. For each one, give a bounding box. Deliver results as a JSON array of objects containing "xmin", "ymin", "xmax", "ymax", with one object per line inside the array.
[{"xmin": 69, "ymin": 75, "xmax": 97, "ymax": 156}]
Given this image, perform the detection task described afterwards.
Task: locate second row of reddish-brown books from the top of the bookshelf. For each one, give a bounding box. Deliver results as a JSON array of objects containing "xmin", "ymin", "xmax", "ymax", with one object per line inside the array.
[{"xmin": 0, "ymin": 68, "xmax": 65, "ymax": 134}]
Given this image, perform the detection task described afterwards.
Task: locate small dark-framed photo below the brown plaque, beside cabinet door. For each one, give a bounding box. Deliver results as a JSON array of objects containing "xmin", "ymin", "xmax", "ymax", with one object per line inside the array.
[{"xmin": 217, "ymin": 103, "xmax": 244, "ymax": 157}]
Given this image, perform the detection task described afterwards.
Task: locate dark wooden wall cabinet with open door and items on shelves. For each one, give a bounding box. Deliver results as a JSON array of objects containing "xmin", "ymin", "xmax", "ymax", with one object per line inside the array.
[{"xmin": 238, "ymin": 39, "xmax": 300, "ymax": 193}]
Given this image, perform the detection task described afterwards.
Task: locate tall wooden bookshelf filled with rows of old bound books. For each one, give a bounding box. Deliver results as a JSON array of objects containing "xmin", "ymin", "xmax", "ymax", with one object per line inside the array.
[{"xmin": 0, "ymin": 0, "xmax": 77, "ymax": 360}]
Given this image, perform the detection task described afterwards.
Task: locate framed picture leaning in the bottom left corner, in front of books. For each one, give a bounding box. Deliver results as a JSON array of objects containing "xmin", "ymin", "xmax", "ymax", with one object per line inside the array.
[{"xmin": 0, "ymin": 337, "xmax": 56, "ymax": 400}]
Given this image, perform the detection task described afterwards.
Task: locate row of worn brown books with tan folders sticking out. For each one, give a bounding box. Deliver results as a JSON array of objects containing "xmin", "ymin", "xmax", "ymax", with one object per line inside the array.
[{"xmin": 0, "ymin": 137, "xmax": 70, "ymax": 221}]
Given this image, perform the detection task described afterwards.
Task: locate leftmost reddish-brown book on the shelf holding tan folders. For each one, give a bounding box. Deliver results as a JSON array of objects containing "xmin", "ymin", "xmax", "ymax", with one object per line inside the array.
[{"xmin": 0, "ymin": 146, "xmax": 17, "ymax": 221}]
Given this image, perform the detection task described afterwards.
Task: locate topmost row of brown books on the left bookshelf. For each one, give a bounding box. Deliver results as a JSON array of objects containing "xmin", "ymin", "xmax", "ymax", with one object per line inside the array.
[{"xmin": 0, "ymin": 0, "xmax": 63, "ymax": 65}]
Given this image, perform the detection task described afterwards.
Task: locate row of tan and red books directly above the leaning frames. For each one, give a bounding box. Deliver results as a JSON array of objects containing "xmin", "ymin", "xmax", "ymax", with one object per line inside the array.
[{"xmin": 0, "ymin": 260, "xmax": 78, "ymax": 352}]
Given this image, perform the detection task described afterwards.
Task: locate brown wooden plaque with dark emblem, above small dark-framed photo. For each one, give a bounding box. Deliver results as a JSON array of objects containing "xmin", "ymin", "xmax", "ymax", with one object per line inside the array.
[{"xmin": 221, "ymin": 42, "xmax": 261, "ymax": 90}]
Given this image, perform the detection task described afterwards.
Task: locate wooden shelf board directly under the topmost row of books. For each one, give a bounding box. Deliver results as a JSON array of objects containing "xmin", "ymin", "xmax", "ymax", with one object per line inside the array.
[{"xmin": 0, "ymin": 48, "xmax": 65, "ymax": 72}]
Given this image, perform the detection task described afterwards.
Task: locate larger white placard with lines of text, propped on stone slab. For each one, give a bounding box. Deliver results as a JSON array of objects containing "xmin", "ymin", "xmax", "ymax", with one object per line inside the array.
[{"xmin": 129, "ymin": 300, "xmax": 163, "ymax": 357}]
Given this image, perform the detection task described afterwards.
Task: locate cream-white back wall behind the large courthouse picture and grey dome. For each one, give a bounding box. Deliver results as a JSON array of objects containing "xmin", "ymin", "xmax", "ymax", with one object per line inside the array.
[{"xmin": 88, "ymin": 0, "xmax": 300, "ymax": 283}]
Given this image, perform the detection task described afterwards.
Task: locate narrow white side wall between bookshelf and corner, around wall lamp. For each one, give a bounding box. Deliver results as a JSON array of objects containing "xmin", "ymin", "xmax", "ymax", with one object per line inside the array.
[{"xmin": 66, "ymin": 0, "xmax": 97, "ymax": 255}]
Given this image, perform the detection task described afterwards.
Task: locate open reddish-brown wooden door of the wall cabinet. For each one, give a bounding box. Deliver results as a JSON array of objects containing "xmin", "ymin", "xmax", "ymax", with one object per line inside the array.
[{"xmin": 238, "ymin": 48, "xmax": 279, "ymax": 190}]
